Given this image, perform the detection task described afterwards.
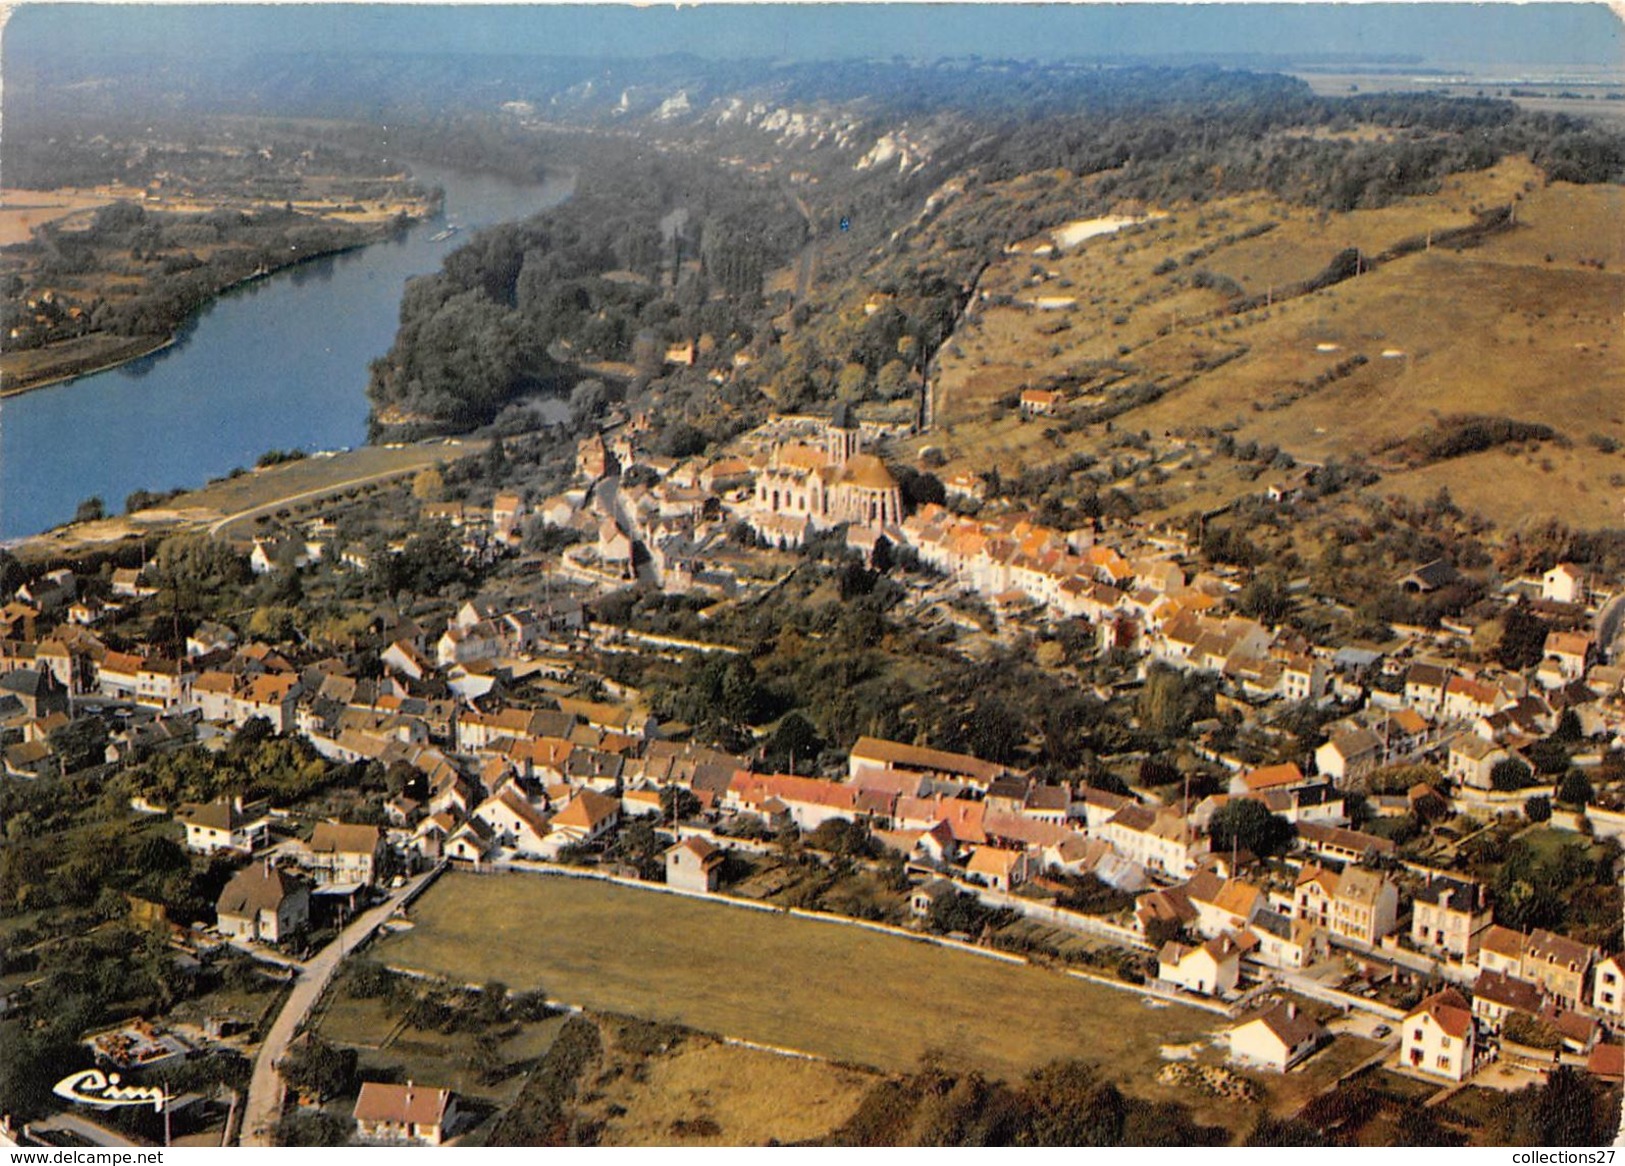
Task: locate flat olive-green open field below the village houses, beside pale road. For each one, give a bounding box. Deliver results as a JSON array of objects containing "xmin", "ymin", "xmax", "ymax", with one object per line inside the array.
[{"xmin": 375, "ymin": 874, "xmax": 1222, "ymax": 1093}]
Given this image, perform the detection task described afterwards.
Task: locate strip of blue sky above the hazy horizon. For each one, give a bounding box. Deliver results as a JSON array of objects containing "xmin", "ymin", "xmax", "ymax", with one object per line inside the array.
[{"xmin": 3, "ymin": 2, "xmax": 1625, "ymax": 68}]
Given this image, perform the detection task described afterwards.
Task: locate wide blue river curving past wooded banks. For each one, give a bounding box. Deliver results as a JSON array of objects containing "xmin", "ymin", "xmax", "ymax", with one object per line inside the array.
[{"xmin": 0, "ymin": 166, "xmax": 572, "ymax": 539}]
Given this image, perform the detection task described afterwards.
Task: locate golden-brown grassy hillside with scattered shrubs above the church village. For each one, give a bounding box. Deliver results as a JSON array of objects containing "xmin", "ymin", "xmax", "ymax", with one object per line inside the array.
[{"xmin": 917, "ymin": 158, "xmax": 1625, "ymax": 526}]
